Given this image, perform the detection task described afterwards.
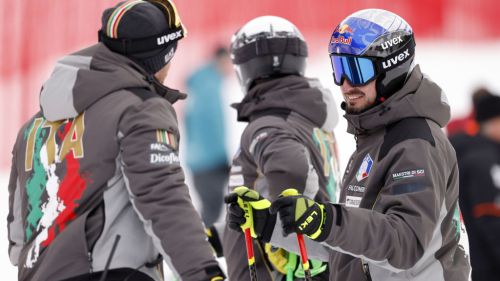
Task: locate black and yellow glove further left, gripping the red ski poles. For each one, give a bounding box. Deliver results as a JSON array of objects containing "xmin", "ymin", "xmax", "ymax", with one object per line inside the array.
[{"xmin": 224, "ymin": 186, "xmax": 276, "ymax": 242}]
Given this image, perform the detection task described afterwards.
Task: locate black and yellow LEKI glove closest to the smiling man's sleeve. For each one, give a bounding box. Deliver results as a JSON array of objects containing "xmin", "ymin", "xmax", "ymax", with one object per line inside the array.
[{"xmin": 270, "ymin": 189, "xmax": 333, "ymax": 242}]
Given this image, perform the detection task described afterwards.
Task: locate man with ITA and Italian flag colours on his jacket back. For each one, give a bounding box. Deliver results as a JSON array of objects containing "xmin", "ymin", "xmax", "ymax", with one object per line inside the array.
[{"xmin": 7, "ymin": 0, "xmax": 224, "ymax": 281}]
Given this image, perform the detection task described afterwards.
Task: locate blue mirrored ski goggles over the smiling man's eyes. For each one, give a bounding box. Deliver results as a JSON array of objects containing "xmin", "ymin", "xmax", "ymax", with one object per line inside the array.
[{"xmin": 330, "ymin": 54, "xmax": 377, "ymax": 86}]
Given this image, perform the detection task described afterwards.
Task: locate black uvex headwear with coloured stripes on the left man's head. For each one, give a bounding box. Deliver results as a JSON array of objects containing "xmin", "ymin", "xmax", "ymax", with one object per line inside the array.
[{"xmin": 100, "ymin": 0, "xmax": 183, "ymax": 74}]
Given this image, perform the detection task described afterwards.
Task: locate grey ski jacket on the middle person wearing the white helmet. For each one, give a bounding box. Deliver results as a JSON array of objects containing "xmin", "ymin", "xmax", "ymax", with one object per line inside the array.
[{"xmin": 222, "ymin": 76, "xmax": 339, "ymax": 281}]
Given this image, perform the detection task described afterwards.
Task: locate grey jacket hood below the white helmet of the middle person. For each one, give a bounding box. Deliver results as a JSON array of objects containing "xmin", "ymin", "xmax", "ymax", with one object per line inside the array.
[{"xmin": 233, "ymin": 75, "xmax": 338, "ymax": 130}]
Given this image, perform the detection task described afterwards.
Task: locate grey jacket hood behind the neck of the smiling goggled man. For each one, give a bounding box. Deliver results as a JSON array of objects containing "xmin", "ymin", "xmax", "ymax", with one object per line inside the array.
[{"xmin": 344, "ymin": 65, "xmax": 450, "ymax": 135}]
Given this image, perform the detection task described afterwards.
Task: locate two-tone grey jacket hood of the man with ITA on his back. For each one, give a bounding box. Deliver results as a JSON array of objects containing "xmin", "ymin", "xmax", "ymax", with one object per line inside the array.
[{"xmin": 40, "ymin": 43, "xmax": 185, "ymax": 121}]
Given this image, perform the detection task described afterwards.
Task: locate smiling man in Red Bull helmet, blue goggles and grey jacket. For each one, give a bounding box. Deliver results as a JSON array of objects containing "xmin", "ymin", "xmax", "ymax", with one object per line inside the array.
[{"xmin": 225, "ymin": 9, "xmax": 470, "ymax": 281}]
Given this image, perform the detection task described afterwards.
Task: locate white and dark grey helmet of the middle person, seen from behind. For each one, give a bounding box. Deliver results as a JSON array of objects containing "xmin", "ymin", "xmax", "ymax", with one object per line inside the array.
[{"xmin": 230, "ymin": 16, "xmax": 307, "ymax": 93}]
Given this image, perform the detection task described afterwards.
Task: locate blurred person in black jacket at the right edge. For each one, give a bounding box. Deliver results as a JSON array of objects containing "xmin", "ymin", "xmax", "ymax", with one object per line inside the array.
[{"xmin": 450, "ymin": 95, "xmax": 500, "ymax": 281}]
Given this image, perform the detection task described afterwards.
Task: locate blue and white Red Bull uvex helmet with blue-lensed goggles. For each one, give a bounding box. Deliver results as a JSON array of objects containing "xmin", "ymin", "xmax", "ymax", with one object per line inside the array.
[{"xmin": 328, "ymin": 9, "xmax": 415, "ymax": 102}]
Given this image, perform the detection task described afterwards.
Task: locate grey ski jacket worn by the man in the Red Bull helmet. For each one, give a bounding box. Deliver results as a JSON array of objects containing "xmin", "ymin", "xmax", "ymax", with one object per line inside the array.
[{"xmin": 271, "ymin": 66, "xmax": 470, "ymax": 281}]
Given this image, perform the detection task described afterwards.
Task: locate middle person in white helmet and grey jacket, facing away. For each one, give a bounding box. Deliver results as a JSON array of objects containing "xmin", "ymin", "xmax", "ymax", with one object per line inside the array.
[{"xmin": 223, "ymin": 16, "xmax": 339, "ymax": 281}]
